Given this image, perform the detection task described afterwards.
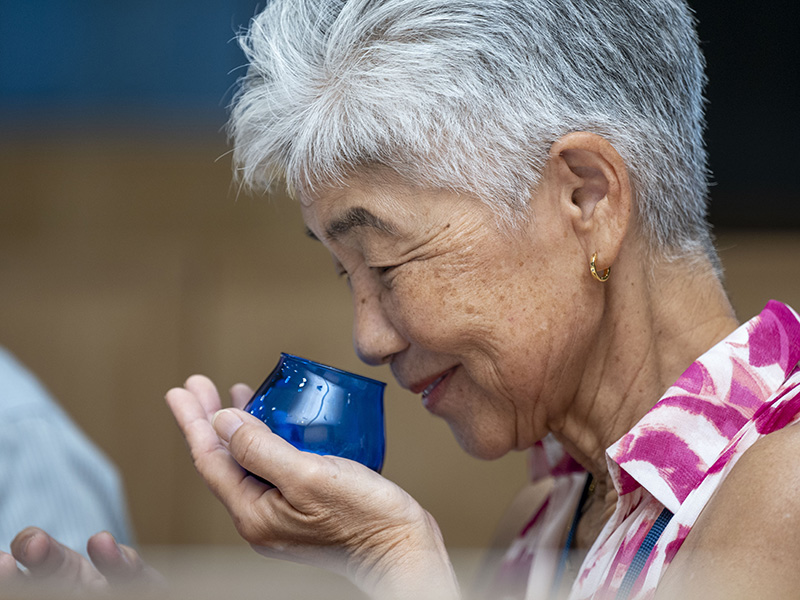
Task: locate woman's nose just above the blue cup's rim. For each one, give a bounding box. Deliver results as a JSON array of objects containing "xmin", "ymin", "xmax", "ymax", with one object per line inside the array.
[{"xmin": 353, "ymin": 286, "xmax": 408, "ymax": 366}]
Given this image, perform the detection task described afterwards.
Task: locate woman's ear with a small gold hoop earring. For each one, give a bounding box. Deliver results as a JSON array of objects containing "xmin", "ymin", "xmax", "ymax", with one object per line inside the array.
[{"xmin": 550, "ymin": 131, "xmax": 633, "ymax": 269}]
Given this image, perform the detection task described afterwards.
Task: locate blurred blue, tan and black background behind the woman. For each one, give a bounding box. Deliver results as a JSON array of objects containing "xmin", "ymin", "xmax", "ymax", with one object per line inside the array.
[{"xmin": 0, "ymin": 0, "xmax": 800, "ymax": 576}]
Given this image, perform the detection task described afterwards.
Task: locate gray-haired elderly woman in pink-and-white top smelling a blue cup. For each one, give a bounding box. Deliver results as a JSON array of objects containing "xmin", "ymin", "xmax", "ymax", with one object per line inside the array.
[{"xmin": 1, "ymin": 0, "xmax": 800, "ymax": 599}]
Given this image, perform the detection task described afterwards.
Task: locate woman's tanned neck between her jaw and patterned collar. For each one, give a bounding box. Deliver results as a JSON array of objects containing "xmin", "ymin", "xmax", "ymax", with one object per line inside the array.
[{"xmin": 550, "ymin": 248, "xmax": 738, "ymax": 488}]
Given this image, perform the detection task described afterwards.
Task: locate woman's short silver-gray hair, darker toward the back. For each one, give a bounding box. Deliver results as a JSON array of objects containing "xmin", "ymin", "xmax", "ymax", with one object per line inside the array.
[{"xmin": 229, "ymin": 0, "xmax": 714, "ymax": 257}]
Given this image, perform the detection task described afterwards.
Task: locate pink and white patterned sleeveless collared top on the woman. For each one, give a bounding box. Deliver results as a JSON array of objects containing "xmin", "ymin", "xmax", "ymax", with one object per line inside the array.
[{"xmin": 497, "ymin": 300, "xmax": 800, "ymax": 600}]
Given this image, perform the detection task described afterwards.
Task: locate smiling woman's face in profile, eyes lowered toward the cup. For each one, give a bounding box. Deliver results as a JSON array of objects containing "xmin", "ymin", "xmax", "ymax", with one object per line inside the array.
[{"xmin": 303, "ymin": 178, "xmax": 589, "ymax": 458}]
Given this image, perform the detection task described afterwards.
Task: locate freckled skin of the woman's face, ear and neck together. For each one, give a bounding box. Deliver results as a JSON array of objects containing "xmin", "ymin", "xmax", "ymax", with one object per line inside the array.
[{"xmin": 301, "ymin": 132, "xmax": 737, "ymax": 504}]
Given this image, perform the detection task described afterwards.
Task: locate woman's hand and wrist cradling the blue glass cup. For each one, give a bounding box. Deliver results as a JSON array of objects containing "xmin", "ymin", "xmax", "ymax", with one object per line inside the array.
[{"xmin": 167, "ymin": 375, "xmax": 458, "ymax": 600}]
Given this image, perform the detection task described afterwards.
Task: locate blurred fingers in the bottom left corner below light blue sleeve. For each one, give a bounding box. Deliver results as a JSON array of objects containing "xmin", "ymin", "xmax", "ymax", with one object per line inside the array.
[{"xmin": 0, "ymin": 527, "xmax": 163, "ymax": 597}]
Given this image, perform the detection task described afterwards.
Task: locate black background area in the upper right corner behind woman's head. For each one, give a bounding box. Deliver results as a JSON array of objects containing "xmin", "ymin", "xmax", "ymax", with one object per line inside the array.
[{"xmin": 690, "ymin": 0, "xmax": 800, "ymax": 228}]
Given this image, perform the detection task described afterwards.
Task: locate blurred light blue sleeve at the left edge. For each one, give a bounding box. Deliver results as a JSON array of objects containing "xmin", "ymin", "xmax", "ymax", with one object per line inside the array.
[{"xmin": 0, "ymin": 348, "xmax": 132, "ymax": 555}]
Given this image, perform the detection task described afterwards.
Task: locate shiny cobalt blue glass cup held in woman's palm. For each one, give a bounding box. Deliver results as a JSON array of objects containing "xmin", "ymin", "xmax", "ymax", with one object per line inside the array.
[{"xmin": 244, "ymin": 353, "xmax": 386, "ymax": 473}]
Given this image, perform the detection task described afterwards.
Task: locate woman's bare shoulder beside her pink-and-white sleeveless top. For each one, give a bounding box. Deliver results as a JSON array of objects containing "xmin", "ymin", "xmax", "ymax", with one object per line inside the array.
[{"xmin": 664, "ymin": 425, "xmax": 800, "ymax": 598}]
